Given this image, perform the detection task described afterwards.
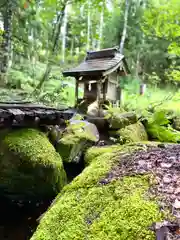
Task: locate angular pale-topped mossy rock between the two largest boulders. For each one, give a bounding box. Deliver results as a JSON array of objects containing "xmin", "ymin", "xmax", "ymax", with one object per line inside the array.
[{"xmin": 56, "ymin": 120, "xmax": 99, "ymax": 163}]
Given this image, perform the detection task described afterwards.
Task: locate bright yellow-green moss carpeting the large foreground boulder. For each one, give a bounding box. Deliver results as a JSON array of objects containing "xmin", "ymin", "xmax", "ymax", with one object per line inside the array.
[{"xmin": 31, "ymin": 144, "xmax": 162, "ymax": 240}]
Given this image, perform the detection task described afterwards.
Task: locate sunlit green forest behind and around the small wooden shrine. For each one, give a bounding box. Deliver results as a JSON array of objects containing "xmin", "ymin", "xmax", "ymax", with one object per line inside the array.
[{"xmin": 0, "ymin": 0, "xmax": 180, "ymax": 109}]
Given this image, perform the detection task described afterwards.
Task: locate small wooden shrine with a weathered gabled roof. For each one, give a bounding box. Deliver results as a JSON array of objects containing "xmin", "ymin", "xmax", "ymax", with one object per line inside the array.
[{"xmin": 63, "ymin": 48, "xmax": 129, "ymax": 109}]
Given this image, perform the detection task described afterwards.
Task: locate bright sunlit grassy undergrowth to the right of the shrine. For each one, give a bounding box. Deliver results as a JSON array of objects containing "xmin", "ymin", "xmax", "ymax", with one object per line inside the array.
[{"xmin": 122, "ymin": 83, "xmax": 180, "ymax": 117}]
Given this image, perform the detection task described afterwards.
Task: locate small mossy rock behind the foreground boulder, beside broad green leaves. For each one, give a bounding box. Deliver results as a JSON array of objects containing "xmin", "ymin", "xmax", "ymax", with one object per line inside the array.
[{"xmin": 118, "ymin": 122, "xmax": 148, "ymax": 143}]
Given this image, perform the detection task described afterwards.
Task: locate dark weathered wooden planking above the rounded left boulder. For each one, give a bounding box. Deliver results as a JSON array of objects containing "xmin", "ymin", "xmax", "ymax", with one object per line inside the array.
[{"xmin": 0, "ymin": 102, "xmax": 72, "ymax": 128}]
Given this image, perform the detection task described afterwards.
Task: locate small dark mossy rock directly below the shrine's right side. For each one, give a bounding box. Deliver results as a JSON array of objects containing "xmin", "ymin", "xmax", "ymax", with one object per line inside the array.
[{"xmin": 108, "ymin": 112, "xmax": 137, "ymax": 129}]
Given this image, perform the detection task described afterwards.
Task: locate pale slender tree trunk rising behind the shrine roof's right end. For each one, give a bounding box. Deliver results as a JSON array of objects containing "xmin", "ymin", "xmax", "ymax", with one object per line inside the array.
[{"xmin": 119, "ymin": 0, "xmax": 129, "ymax": 54}]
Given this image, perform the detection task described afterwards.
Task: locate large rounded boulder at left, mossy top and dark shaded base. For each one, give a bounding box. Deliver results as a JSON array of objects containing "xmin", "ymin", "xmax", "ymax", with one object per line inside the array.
[{"xmin": 0, "ymin": 129, "xmax": 66, "ymax": 201}]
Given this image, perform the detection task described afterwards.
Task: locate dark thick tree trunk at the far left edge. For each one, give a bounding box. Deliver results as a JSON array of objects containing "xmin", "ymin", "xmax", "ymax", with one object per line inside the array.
[{"xmin": 0, "ymin": 0, "xmax": 13, "ymax": 85}]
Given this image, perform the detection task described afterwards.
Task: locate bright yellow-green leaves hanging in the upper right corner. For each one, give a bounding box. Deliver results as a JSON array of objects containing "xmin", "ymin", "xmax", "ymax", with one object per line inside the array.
[{"xmin": 142, "ymin": 0, "xmax": 180, "ymax": 83}]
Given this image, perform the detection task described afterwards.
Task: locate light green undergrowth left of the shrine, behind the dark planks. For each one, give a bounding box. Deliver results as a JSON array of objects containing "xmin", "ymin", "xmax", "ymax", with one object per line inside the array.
[{"xmin": 6, "ymin": 59, "xmax": 76, "ymax": 107}]
